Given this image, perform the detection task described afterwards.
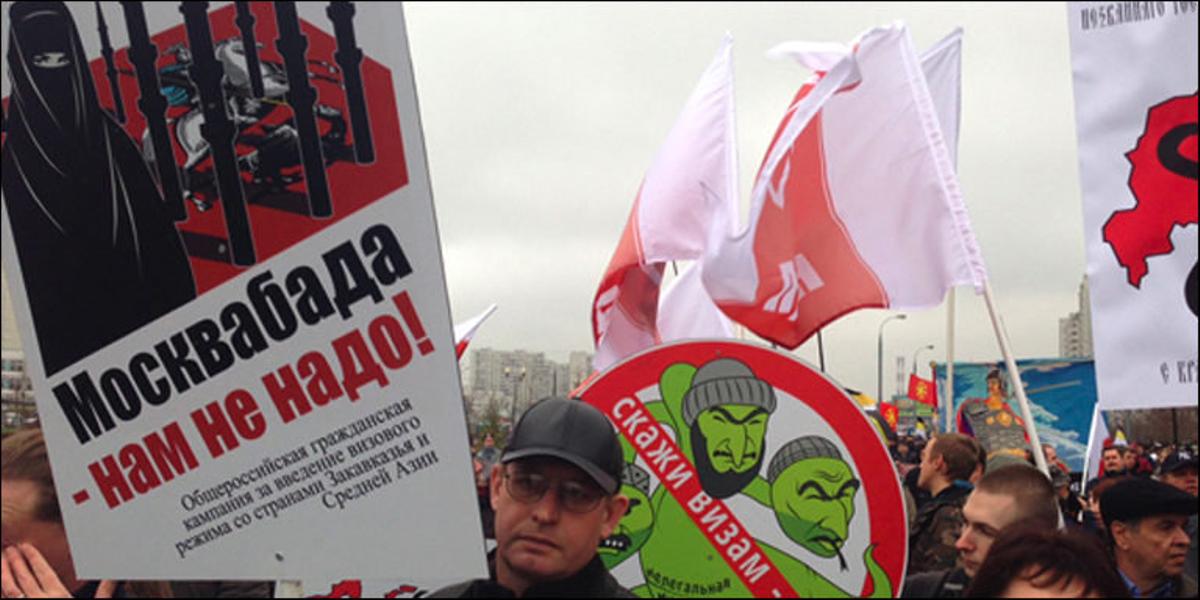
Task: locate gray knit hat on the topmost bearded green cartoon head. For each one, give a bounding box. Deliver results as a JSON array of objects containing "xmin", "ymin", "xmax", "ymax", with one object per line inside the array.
[{"xmin": 683, "ymin": 359, "xmax": 775, "ymax": 427}]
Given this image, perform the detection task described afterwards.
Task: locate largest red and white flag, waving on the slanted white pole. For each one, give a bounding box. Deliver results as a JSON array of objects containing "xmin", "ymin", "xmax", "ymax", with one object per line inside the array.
[{"xmin": 703, "ymin": 25, "xmax": 986, "ymax": 348}]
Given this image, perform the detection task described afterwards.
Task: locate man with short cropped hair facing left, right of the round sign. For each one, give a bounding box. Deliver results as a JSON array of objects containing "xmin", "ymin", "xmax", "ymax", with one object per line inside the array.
[{"xmin": 902, "ymin": 464, "xmax": 1058, "ymax": 598}]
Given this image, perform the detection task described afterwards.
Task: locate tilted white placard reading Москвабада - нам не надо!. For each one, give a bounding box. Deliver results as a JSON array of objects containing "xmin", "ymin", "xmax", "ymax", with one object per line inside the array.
[{"xmin": 2, "ymin": 2, "xmax": 486, "ymax": 580}]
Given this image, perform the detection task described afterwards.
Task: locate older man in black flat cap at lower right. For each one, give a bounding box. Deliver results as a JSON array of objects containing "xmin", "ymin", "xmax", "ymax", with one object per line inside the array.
[{"xmin": 1100, "ymin": 478, "xmax": 1196, "ymax": 598}]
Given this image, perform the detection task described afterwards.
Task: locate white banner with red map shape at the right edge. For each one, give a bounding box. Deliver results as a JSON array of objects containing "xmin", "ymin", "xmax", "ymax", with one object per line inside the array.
[{"xmin": 1067, "ymin": 2, "xmax": 1198, "ymax": 410}]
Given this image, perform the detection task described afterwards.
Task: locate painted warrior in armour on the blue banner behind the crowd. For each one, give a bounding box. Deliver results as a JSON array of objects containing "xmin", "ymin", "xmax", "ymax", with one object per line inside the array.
[{"xmin": 958, "ymin": 368, "xmax": 1030, "ymax": 462}]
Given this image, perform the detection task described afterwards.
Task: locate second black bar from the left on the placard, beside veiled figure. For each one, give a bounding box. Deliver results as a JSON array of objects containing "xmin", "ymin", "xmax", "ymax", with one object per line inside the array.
[{"xmin": 121, "ymin": 2, "xmax": 187, "ymax": 221}]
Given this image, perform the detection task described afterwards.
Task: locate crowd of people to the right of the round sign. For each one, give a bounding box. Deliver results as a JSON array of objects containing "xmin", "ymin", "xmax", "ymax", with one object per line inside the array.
[{"xmin": 889, "ymin": 433, "xmax": 1198, "ymax": 598}]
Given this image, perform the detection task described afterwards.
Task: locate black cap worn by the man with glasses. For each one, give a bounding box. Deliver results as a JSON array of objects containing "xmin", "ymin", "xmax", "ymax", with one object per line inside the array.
[{"xmin": 500, "ymin": 397, "xmax": 625, "ymax": 494}]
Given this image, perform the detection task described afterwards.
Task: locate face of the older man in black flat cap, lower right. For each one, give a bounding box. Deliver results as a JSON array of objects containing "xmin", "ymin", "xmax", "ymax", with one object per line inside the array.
[{"xmin": 1112, "ymin": 515, "xmax": 1192, "ymax": 577}]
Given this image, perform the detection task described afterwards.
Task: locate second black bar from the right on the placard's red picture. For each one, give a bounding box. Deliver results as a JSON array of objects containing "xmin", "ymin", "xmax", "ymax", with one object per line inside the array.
[{"xmin": 275, "ymin": 2, "xmax": 334, "ymax": 218}]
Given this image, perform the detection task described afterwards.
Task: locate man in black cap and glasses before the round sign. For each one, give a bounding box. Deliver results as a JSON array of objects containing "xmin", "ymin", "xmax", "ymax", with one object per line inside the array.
[{"xmin": 433, "ymin": 398, "xmax": 634, "ymax": 598}]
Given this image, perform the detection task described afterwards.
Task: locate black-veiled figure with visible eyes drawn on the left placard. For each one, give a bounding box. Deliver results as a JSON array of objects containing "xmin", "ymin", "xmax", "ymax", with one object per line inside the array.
[{"xmin": 2, "ymin": 2, "xmax": 196, "ymax": 374}]
